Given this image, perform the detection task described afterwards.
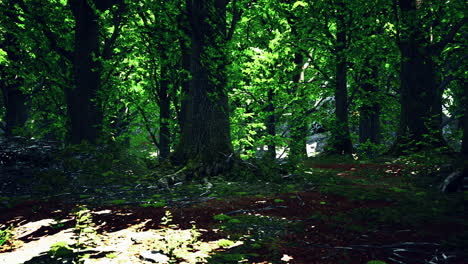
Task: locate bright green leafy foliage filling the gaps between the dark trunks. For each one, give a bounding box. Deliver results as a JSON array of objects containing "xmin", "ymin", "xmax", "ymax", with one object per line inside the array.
[{"xmin": 0, "ymin": 0, "xmax": 464, "ymax": 169}]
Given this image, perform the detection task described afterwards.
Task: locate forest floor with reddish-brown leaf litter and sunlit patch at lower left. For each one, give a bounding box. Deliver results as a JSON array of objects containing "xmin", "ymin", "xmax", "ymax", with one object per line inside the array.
[{"xmin": 0, "ymin": 144, "xmax": 468, "ymax": 264}]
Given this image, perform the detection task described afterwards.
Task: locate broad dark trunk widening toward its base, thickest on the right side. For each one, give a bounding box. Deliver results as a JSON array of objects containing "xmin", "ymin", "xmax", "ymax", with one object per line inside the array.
[{"xmin": 393, "ymin": 0, "xmax": 446, "ymax": 153}]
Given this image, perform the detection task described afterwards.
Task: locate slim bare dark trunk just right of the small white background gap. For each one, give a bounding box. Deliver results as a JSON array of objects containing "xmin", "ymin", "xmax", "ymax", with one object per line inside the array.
[{"xmin": 331, "ymin": 4, "xmax": 353, "ymax": 155}]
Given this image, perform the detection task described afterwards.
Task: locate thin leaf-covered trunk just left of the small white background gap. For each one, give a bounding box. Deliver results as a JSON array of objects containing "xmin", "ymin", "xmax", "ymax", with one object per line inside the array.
[{"xmin": 290, "ymin": 52, "xmax": 307, "ymax": 161}]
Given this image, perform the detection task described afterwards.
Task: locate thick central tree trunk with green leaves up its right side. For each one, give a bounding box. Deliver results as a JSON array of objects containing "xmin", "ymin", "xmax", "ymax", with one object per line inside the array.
[{"xmin": 173, "ymin": 0, "xmax": 233, "ymax": 169}]
